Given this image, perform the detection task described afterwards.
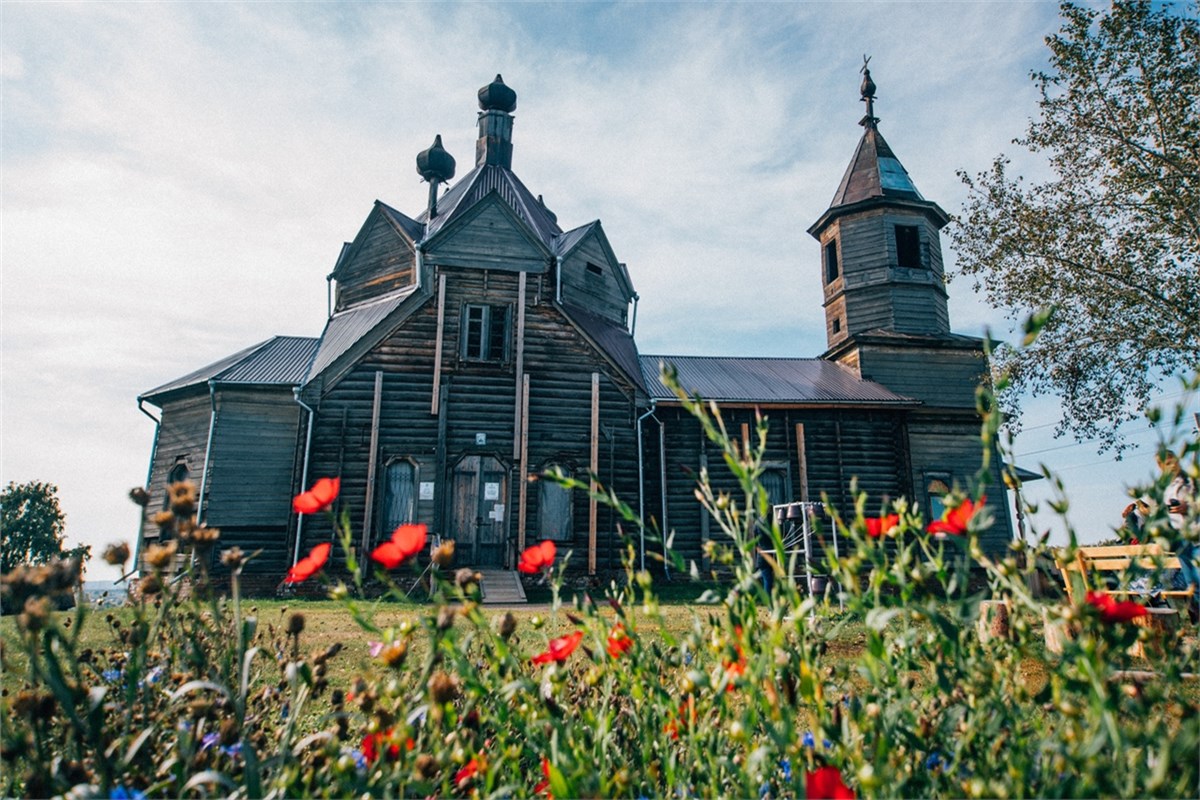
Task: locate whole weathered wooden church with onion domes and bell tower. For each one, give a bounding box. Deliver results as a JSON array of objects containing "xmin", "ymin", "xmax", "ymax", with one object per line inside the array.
[{"xmin": 138, "ymin": 72, "xmax": 1012, "ymax": 590}]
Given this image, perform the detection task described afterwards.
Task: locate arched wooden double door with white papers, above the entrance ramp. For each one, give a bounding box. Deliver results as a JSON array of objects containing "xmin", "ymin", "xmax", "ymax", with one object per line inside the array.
[{"xmin": 449, "ymin": 456, "xmax": 509, "ymax": 567}]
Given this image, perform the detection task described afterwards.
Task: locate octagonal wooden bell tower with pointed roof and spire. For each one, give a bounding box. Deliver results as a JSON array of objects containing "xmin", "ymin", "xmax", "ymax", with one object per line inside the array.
[{"xmin": 809, "ymin": 62, "xmax": 950, "ymax": 351}]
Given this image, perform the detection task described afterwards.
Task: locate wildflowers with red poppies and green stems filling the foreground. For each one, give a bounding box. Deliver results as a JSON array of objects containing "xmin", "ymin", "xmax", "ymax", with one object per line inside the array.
[{"xmin": 0, "ymin": 367, "xmax": 1200, "ymax": 798}]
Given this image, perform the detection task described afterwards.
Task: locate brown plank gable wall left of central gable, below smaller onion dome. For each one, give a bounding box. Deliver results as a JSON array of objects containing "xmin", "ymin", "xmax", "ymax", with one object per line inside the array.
[{"xmin": 334, "ymin": 205, "xmax": 416, "ymax": 311}]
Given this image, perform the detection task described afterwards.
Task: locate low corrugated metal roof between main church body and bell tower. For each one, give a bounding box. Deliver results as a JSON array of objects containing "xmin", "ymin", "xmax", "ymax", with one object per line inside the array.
[{"xmin": 640, "ymin": 355, "xmax": 917, "ymax": 405}]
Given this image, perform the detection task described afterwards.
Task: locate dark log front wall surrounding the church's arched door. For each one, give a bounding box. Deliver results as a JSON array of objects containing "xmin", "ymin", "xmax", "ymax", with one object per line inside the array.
[{"xmin": 301, "ymin": 267, "xmax": 637, "ymax": 569}]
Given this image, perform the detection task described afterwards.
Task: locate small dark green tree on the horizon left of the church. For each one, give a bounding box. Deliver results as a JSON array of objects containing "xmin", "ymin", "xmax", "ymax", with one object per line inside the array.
[{"xmin": 0, "ymin": 481, "xmax": 72, "ymax": 572}]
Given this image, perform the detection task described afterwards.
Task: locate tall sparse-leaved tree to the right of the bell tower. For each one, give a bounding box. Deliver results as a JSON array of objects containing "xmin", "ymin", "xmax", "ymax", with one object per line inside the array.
[{"xmin": 953, "ymin": 2, "xmax": 1200, "ymax": 452}]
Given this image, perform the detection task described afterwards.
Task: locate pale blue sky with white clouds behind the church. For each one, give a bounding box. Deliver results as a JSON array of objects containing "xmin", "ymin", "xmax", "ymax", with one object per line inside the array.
[{"xmin": 0, "ymin": 1, "xmax": 1190, "ymax": 578}]
